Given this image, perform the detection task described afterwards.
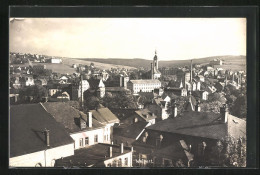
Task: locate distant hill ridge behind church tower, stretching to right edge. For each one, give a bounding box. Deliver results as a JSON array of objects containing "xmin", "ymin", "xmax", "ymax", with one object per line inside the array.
[{"xmin": 78, "ymin": 55, "xmax": 246, "ymax": 70}]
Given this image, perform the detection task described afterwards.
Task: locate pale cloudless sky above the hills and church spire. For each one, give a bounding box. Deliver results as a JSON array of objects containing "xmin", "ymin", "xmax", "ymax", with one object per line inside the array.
[{"xmin": 9, "ymin": 18, "xmax": 246, "ymax": 60}]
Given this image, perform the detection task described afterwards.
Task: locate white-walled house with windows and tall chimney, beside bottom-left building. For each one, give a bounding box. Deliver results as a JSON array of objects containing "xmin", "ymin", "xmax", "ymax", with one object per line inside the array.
[{"xmin": 43, "ymin": 102, "xmax": 118, "ymax": 149}]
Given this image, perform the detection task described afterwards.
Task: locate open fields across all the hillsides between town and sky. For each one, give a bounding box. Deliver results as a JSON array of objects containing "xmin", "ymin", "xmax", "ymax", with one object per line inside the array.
[{"xmin": 12, "ymin": 56, "xmax": 246, "ymax": 74}]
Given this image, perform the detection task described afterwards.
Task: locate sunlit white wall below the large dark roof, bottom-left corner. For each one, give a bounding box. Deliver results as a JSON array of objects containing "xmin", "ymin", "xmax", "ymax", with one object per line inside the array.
[{"xmin": 9, "ymin": 143, "xmax": 74, "ymax": 167}]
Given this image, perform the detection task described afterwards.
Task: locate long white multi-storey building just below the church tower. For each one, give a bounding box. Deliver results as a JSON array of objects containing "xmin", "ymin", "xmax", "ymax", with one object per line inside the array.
[{"xmin": 127, "ymin": 79, "xmax": 161, "ymax": 94}]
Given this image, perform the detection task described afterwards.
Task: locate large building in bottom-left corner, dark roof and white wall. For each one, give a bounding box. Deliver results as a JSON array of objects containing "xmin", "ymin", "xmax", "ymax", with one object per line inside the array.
[{"xmin": 9, "ymin": 104, "xmax": 74, "ymax": 167}]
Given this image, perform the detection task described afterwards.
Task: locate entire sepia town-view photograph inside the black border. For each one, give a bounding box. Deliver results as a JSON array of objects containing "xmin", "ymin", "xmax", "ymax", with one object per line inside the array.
[{"xmin": 9, "ymin": 17, "xmax": 248, "ymax": 168}]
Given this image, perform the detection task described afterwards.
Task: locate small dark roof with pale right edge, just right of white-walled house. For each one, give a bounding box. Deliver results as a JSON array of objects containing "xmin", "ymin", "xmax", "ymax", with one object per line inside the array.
[{"xmin": 113, "ymin": 121, "xmax": 148, "ymax": 139}]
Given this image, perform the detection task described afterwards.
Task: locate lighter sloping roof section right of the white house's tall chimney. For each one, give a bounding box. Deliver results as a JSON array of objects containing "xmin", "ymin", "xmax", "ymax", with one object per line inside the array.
[{"xmin": 90, "ymin": 107, "xmax": 119, "ymax": 124}]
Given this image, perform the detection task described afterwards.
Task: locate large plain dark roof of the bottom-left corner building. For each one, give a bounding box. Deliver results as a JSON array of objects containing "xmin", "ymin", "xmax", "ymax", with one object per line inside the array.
[{"xmin": 10, "ymin": 104, "xmax": 74, "ymax": 157}]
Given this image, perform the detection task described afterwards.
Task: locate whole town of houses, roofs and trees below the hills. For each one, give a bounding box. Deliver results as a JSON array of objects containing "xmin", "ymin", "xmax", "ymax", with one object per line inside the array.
[{"xmin": 9, "ymin": 51, "xmax": 247, "ymax": 168}]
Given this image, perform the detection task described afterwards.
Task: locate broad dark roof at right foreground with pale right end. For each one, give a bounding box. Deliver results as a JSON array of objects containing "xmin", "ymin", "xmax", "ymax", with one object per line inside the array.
[{"xmin": 148, "ymin": 111, "xmax": 246, "ymax": 139}]
